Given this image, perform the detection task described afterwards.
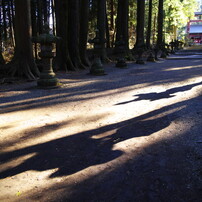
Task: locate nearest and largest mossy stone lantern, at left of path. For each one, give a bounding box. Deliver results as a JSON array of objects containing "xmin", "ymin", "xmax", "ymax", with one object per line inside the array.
[{"xmin": 32, "ymin": 24, "xmax": 60, "ymax": 88}]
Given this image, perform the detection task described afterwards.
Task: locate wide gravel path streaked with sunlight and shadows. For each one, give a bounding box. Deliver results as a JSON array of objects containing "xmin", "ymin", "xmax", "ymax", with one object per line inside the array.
[{"xmin": 0, "ymin": 46, "xmax": 202, "ymax": 202}]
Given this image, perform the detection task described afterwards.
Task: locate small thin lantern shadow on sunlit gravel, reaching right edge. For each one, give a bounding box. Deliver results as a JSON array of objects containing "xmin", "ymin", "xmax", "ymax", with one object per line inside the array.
[{"xmin": 116, "ymin": 82, "xmax": 202, "ymax": 105}]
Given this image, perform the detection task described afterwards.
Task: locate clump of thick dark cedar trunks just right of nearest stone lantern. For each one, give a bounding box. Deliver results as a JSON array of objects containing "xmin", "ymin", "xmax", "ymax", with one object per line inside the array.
[{"xmin": 55, "ymin": 0, "xmax": 88, "ymax": 71}]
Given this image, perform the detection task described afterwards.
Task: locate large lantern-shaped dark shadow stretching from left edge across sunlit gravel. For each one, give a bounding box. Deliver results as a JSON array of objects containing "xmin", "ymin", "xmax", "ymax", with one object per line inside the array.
[{"xmin": 0, "ymin": 100, "xmax": 174, "ymax": 178}]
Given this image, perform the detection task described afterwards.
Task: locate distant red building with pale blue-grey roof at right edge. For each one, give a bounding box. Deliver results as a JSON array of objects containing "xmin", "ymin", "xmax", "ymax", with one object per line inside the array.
[{"xmin": 187, "ymin": 12, "xmax": 202, "ymax": 43}]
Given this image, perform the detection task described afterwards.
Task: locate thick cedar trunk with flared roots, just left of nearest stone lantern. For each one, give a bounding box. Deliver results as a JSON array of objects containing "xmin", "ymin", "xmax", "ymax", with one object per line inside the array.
[{"xmin": 8, "ymin": 0, "xmax": 39, "ymax": 79}]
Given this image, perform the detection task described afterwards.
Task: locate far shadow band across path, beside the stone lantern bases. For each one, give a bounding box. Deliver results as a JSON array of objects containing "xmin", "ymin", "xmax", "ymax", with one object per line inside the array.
[{"xmin": 0, "ymin": 60, "xmax": 201, "ymax": 114}]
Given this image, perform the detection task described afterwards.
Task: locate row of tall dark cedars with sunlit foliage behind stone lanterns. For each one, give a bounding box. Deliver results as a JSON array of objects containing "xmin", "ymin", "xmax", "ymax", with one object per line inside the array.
[{"xmin": 0, "ymin": 0, "xmax": 196, "ymax": 79}]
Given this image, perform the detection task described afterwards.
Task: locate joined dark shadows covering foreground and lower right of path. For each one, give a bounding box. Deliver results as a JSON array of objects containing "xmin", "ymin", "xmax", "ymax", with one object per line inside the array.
[{"xmin": 0, "ymin": 96, "xmax": 202, "ymax": 202}]
